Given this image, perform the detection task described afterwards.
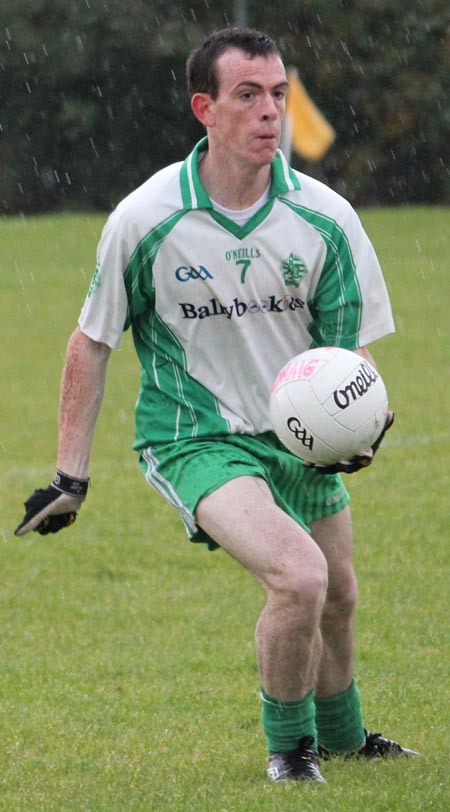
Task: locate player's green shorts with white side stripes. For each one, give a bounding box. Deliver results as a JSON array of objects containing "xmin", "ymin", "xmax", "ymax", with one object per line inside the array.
[{"xmin": 140, "ymin": 432, "xmax": 350, "ymax": 550}]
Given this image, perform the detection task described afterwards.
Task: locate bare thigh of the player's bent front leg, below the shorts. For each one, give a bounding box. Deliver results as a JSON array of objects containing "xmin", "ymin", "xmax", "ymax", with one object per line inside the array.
[{"xmin": 196, "ymin": 476, "xmax": 326, "ymax": 589}]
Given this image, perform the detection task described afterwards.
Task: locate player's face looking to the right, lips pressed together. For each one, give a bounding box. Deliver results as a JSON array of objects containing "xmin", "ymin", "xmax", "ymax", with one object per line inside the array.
[{"xmin": 208, "ymin": 48, "xmax": 288, "ymax": 166}]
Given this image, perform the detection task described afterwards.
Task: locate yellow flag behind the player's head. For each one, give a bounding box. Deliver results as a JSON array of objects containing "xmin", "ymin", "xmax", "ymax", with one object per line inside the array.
[{"xmin": 281, "ymin": 68, "xmax": 336, "ymax": 161}]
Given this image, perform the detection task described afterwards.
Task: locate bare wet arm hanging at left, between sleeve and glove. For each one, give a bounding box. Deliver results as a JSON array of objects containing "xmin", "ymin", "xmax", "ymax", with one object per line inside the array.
[{"xmin": 57, "ymin": 327, "xmax": 111, "ymax": 479}]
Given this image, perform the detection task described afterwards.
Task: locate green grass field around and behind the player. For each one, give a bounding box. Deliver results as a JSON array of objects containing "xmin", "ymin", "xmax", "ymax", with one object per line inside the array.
[{"xmin": 0, "ymin": 208, "xmax": 450, "ymax": 812}]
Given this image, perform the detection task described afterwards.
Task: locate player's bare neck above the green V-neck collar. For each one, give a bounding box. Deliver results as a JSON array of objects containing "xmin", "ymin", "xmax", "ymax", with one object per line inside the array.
[{"xmin": 199, "ymin": 152, "xmax": 271, "ymax": 211}]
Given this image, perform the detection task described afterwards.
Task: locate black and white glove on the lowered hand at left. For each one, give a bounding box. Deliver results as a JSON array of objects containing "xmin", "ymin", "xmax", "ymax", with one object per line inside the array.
[{"xmin": 14, "ymin": 471, "xmax": 89, "ymax": 536}]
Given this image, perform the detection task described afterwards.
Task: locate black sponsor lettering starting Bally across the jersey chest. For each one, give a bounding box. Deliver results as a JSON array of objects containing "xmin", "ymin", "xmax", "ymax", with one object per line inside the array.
[{"xmin": 179, "ymin": 296, "xmax": 305, "ymax": 319}]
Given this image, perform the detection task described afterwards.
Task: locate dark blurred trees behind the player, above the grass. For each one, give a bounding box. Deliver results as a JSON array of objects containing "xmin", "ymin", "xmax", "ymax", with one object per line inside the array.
[{"xmin": 0, "ymin": 0, "xmax": 450, "ymax": 214}]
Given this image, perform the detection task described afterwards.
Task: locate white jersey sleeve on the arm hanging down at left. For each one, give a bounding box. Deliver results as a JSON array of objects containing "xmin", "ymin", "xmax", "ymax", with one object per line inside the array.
[{"xmin": 78, "ymin": 212, "xmax": 130, "ymax": 349}]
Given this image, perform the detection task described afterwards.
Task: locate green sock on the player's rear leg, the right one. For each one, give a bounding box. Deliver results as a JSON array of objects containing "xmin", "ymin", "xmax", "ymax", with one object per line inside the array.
[{"xmin": 315, "ymin": 680, "xmax": 364, "ymax": 753}]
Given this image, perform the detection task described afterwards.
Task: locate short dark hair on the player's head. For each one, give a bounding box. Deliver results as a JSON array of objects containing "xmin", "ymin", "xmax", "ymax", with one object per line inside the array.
[{"xmin": 186, "ymin": 26, "xmax": 281, "ymax": 99}]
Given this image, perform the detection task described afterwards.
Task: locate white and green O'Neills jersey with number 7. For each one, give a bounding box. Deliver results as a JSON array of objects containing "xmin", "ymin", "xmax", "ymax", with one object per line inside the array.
[{"xmin": 79, "ymin": 139, "xmax": 394, "ymax": 448}]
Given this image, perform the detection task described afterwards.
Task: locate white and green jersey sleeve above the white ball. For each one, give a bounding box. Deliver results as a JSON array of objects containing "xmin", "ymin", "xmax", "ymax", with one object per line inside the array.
[{"xmin": 309, "ymin": 205, "xmax": 395, "ymax": 350}]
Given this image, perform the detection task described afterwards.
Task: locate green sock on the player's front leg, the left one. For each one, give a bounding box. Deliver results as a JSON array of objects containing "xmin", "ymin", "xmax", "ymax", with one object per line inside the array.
[{"xmin": 261, "ymin": 690, "xmax": 317, "ymax": 753}]
